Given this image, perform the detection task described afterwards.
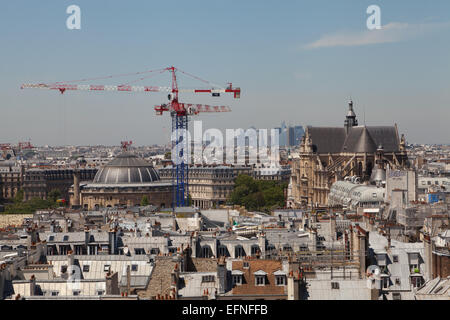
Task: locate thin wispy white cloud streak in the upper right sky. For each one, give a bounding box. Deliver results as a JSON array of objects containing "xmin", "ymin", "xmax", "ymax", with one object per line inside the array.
[{"xmin": 303, "ymin": 22, "xmax": 450, "ymax": 49}]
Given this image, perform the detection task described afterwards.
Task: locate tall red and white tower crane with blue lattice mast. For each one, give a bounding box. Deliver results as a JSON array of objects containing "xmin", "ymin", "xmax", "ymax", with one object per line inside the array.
[{"xmin": 21, "ymin": 66, "xmax": 241, "ymax": 207}]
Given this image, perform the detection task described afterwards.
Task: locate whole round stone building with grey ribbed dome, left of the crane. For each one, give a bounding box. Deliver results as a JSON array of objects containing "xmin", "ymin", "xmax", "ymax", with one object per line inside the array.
[{"xmin": 69, "ymin": 152, "xmax": 172, "ymax": 210}]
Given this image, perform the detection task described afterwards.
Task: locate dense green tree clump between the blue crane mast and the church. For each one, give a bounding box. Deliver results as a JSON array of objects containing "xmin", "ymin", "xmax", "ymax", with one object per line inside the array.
[{"xmin": 230, "ymin": 175, "xmax": 287, "ymax": 212}]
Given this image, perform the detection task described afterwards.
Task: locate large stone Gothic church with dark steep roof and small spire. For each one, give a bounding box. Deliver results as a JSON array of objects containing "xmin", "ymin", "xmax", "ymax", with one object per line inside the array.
[{"xmin": 291, "ymin": 101, "xmax": 408, "ymax": 208}]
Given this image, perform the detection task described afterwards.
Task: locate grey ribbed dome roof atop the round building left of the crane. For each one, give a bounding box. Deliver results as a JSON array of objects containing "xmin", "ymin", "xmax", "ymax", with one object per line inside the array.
[{"xmin": 94, "ymin": 152, "xmax": 160, "ymax": 184}]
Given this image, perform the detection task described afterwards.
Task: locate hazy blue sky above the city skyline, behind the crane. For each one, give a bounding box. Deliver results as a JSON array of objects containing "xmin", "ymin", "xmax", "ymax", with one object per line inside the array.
[{"xmin": 0, "ymin": 0, "xmax": 450, "ymax": 145}]
